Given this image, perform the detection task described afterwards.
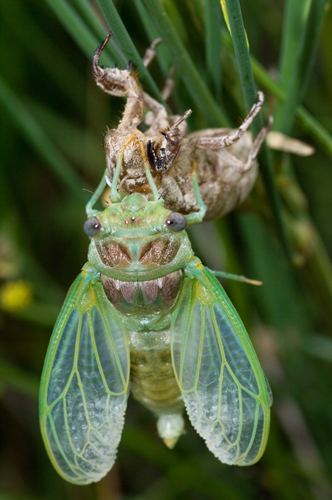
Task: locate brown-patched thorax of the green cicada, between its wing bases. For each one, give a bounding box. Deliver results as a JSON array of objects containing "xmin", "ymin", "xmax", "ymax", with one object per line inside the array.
[{"xmin": 96, "ymin": 229, "xmax": 182, "ymax": 330}]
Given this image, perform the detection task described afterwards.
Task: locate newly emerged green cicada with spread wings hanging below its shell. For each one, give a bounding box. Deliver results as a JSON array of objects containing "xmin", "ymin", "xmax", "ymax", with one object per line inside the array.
[{"xmin": 40, "ymin": 34, "xmax": 272, "ymax": 484}]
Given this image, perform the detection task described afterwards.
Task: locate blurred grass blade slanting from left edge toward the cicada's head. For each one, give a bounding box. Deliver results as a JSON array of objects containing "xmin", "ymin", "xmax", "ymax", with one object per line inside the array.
[{"xmin": 0, "ymin": 77, "xmax": 86, "ymax": 202}]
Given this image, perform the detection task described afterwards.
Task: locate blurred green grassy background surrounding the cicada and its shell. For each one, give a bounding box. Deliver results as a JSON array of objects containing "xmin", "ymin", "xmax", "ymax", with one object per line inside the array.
[{"xmin": 0, "ymin": 0, "xmax": 332, "ymax": 500}]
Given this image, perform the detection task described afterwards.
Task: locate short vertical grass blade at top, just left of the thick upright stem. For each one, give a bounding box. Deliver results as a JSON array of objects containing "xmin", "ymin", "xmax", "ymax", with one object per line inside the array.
[{"xmin": 204, "ymin": 0, "xmax": 222, "ymax": 99}]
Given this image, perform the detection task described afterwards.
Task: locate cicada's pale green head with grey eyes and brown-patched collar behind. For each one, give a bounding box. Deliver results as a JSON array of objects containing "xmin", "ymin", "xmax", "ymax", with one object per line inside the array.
[{"xmin": 84, "ymin": 194, "xmax": 193, "ymax": 281}]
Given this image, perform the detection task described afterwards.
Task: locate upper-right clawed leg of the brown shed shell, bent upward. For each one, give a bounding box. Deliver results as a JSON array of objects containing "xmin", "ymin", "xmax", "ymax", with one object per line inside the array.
[{"xmin": 194, "ymin": 92, "xmax": 264, "ymax": 149}]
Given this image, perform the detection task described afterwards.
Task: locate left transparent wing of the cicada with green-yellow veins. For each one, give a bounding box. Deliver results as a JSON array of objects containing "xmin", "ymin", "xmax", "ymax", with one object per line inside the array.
[{"xmin": 40, "ymin": 270, "xmax": 129, "ymax": 484}]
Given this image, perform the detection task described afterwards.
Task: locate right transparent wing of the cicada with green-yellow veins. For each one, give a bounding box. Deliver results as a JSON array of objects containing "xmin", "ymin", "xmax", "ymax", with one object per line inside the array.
[{"xmin": 171, "ymin": 266, "xmax": 272, "ymax": 465}]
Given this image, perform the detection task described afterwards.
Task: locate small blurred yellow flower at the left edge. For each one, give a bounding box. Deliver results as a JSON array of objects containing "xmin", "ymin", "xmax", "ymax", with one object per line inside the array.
[{"xmin": 0, "ymin": 280, "xmax": 33, "ymax": 312}]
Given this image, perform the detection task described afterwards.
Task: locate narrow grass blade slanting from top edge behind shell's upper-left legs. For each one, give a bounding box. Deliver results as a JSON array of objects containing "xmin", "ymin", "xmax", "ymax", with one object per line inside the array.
[{"xmin": 97, "ymin": 0, "xmax": 164, "ymax": 103}]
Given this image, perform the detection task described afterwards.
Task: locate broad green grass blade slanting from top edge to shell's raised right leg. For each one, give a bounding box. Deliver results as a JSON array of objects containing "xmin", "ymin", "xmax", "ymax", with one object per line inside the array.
[{"xmin": 143, "ymin": 0, "xmax": 228, "ymax": 126}]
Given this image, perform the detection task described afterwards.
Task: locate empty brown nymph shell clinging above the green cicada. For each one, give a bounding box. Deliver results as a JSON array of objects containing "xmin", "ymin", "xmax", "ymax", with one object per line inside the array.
[{"xmin": 93, "ymin": 34, "xmax": 268, "ymax": 220}]
